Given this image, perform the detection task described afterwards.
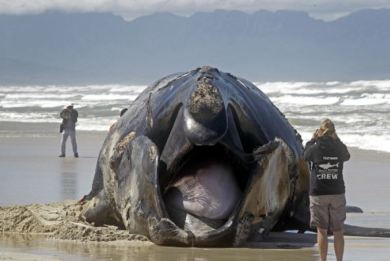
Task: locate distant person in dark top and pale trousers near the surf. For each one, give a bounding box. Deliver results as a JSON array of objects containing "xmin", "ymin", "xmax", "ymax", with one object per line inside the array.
[{"xmin": 59, "ymin": 104, "xmax": 79, "ymax": 158}]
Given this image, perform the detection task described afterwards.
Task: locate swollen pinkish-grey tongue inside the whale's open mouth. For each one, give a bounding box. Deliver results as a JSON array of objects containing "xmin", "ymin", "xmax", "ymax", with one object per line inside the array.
[{"xmin": 164, "ymin": 162, "xmax": 241, "ymax": 231}]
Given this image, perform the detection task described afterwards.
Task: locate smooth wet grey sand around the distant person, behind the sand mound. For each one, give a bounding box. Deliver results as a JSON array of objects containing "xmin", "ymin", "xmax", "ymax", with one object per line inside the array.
[{"xmin": 0, "ymin": 123, "xmax": 106, "ymax": 206}]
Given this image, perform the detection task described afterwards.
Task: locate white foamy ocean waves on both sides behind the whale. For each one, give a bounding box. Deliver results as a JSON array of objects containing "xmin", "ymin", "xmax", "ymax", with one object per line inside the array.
[{"xmin": 0, "ymin": 80, "xmax": 390, "ymax": 152}]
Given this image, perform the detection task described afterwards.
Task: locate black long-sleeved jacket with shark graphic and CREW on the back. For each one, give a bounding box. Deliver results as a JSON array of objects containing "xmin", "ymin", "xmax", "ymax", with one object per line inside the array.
[{"xmin": 304, "ymin": 136, "xmax": 350, "ymax": 196}]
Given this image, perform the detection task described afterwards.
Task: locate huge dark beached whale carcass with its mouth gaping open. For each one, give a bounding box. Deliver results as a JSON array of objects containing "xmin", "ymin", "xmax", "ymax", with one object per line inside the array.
[{"xmin": 84, "ymin": 66, "xmax": 309, "ymax": 246}]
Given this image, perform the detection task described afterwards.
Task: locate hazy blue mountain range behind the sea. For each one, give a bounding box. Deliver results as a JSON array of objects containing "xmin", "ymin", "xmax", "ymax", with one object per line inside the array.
[{"xmin": 0, "ymin": 10, "xmax": 390, "ymax": 85}]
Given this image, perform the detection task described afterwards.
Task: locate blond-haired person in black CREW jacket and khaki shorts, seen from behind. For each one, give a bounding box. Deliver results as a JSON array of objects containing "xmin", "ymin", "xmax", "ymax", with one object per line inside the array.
[{"xmin": 304, "ymin": 119, "xmax": 350, "ymax": 261}]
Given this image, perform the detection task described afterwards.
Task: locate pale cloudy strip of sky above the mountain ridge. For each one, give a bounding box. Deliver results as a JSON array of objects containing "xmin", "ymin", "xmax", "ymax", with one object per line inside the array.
[{"xmin": 0, "ymin": 0, "xmax": 390, "ymax": 20}]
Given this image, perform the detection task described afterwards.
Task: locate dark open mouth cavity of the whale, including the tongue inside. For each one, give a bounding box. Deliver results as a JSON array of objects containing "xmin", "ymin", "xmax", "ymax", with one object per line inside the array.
[{"xmin": 160, "ymin": 145, "xmax": 249, "ymax": 236}]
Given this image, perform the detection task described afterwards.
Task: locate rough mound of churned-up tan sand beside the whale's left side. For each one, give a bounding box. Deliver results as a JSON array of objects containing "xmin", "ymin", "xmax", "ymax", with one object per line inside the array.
[{"xmin": 0, "ymin": 201, "xmax": 148, "ymax": 241}]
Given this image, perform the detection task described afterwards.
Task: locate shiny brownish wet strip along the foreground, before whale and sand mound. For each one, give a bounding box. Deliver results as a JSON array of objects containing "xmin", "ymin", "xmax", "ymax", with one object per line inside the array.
[{"xmin": 0, "ymin": 235, "xmax": 317, "ymax": 261}]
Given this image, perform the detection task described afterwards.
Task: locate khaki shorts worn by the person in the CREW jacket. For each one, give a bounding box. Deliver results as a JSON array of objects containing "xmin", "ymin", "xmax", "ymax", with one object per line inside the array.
[{"xmin": 310, "ymin": 194, "xmax": 346, "ymax": 231}]
